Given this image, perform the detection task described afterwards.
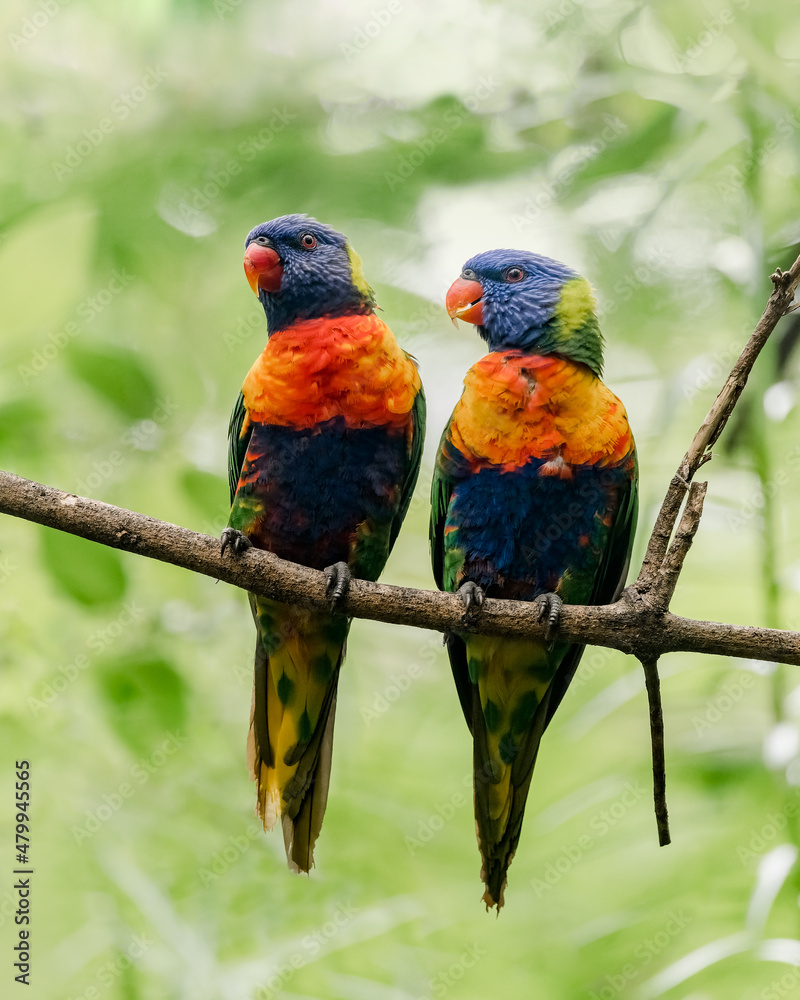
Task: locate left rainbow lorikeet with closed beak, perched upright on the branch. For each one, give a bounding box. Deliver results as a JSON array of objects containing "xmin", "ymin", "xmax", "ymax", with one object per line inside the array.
[{"xmin": 222, "ymin": 215, "xmax": 425, "ymax": 871}]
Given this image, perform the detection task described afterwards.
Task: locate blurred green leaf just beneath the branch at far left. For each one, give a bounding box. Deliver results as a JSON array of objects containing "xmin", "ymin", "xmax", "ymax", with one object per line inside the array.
[{"xmin": 42, "ymin": 528, "xmax": 128, "ymax": 606}]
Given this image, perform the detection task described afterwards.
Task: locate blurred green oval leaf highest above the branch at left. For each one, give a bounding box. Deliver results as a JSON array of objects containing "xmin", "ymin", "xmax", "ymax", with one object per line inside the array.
[{"xmin": 67, "ymin": 345, "xmax": 158, "ymax": 420}]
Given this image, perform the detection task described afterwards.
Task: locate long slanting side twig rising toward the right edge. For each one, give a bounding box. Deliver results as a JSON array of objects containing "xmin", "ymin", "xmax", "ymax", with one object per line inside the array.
[{"xmin": 634, "ymin": 257, "xmax": 800, "ymax": 594}]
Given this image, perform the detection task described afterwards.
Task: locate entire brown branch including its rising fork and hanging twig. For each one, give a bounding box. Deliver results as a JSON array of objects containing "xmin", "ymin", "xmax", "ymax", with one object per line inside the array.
[{"xmin": 0, "ymin": 257, "xmax": 800, "ymax": 844}]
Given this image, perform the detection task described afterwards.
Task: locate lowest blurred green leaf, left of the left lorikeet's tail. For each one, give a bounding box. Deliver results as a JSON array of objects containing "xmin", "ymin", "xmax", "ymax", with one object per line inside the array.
[{"xmin": 96, "ymin": 653, "xmax": 188, "ymax": 752}]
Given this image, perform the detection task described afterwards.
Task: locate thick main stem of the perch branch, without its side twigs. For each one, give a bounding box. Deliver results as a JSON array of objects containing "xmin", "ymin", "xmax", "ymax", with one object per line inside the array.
[{"xmin": 0, "ymin": 472, "xmax": 800, "ymax": 665}]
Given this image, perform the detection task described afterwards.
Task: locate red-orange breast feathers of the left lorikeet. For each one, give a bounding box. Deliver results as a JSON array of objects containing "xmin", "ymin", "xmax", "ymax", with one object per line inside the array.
[{"xmin": 242, "ymin": 316, "xmax": 420, "ymax": 427}]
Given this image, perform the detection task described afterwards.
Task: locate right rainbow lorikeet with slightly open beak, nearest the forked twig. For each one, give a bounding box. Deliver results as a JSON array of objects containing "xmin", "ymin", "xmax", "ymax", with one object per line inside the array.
[{"xmin": 430, "ymin": 250, "xmax": 637, "ymax": 910}]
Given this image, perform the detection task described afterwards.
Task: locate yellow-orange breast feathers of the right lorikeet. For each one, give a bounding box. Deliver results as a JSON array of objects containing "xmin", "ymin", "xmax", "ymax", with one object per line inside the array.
[{"xmin": 450, "ymin": 351, "xmax": 633, "ymax": 468}]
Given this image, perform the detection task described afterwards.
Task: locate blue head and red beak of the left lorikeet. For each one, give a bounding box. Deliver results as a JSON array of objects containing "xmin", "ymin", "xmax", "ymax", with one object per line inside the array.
[{"xmin": 244, "ymin": 215, "xmax": 375, "ymax": 334}]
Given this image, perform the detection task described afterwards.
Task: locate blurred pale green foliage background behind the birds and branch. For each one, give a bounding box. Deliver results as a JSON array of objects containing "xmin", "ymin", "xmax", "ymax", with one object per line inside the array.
[{"xmin": 0, "ymin": 0, "xmax": 800, "ymax": 1000}]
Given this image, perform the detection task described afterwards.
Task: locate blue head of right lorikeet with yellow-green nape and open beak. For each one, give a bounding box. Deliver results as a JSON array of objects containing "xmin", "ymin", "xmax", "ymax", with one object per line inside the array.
[{"xmin": 447, "ymin": 250, "xmax": 603, "ymax": 375}]
